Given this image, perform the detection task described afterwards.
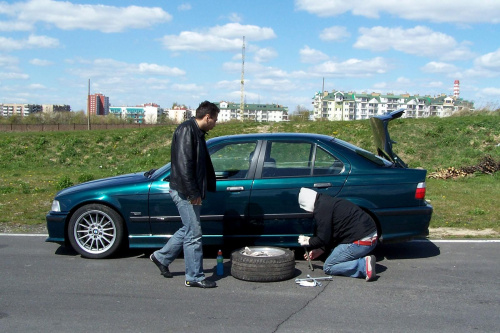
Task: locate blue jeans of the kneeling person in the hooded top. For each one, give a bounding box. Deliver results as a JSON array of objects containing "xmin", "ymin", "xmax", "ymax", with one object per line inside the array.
[{"xmin": 323, "ymin": 242, "xmax": 377, "ymax": 278}]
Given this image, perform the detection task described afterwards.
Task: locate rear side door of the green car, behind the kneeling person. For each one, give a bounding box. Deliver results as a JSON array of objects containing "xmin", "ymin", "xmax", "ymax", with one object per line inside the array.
[{"xmin": 249, "ymin": 139, "xmax": 350, "ymax": 246}]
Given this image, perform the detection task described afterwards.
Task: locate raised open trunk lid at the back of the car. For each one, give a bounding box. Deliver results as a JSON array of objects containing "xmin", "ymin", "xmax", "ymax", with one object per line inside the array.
[{"xmin": 370, "ymin": 109, "xmax": 408, "ymax": 168}]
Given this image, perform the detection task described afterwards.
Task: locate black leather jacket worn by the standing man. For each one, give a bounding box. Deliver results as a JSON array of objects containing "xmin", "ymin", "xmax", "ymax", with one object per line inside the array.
[{"xmin": 170, "ymin": 117, "xmax": 215, "ymax": 200}]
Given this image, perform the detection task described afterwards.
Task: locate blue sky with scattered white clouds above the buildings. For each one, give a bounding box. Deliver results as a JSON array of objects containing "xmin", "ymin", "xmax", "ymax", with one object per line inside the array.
[{"xmin": 0, "ymin": 0, "xmax": 500, "ymax": 111}]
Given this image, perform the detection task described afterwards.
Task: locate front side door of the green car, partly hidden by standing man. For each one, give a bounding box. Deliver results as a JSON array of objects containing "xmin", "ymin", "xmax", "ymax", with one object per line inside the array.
[{"xmin": 149, "ymin": 139, "xmax": 258, "ymax": 245}]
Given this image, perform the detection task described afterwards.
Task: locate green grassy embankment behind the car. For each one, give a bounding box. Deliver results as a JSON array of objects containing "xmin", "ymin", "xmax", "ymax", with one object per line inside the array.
[{"xmin": 0, "ymin": 111, "xmax": 500, "ymax": 236}]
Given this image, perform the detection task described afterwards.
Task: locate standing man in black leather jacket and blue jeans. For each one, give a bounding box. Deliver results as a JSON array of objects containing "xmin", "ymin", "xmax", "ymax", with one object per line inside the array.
[{"xmin": 150, "ymin": 101, "xmax": 220, "ymax": 288}]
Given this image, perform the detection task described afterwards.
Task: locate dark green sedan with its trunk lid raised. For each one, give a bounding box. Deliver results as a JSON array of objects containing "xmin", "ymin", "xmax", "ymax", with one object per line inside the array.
[{"xmin": 46, "ymin": 110, "xmax": 432, "ymax": 258}]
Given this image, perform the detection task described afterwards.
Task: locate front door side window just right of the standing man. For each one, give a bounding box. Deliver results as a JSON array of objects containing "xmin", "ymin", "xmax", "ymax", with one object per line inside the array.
[{"xmin": 210, "ymin": 141, "xmax": 257, "ymax": 179}]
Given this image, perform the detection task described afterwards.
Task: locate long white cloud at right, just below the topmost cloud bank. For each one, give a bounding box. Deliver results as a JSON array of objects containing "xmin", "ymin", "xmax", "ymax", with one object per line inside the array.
[{"xmin": 354, "ymin": 26, "xmax": 472, "ymax": 60}]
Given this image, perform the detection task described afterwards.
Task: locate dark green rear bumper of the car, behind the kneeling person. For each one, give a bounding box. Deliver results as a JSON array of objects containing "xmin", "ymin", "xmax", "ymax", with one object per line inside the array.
[{"xmin": 373, "ymin": 204, "xmax": 433, "ymax": 243}]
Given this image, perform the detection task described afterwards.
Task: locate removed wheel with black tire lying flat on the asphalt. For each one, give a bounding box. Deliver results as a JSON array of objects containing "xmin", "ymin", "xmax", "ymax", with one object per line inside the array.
[{"xmin": 231, "ymin": 246, "xmax": 295, "ymax": 282}]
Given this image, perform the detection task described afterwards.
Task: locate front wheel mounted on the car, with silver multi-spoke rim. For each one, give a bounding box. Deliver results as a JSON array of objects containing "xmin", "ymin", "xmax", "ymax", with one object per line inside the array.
[{"xmin": 68, "ymin": 204, "xmax": 123, "ymax": 259}]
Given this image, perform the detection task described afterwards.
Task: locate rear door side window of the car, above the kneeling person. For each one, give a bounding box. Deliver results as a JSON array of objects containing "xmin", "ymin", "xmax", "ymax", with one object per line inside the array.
[{"xmin": 262, "ymin": 141, "xmax": 314, "ymax": 178}]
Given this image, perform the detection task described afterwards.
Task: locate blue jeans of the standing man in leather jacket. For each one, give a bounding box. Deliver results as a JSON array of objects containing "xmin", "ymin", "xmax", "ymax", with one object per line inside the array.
[{"xmin": 154, "ymin": 190, "xmax": 205, "ymax": 282}]
